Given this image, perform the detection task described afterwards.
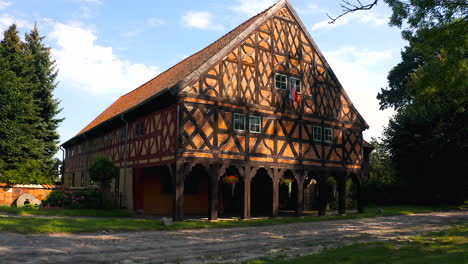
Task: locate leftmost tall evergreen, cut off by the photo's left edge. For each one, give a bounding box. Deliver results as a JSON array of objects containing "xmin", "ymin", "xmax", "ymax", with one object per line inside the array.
[{"xmin": 0, "ymin": 24, "xmax": 41, "ymax": 166}]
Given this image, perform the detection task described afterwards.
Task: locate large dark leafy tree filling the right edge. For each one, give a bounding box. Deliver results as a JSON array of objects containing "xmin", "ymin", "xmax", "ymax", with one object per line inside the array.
[{"xmin": 378, "ymin": 20, "xmax": 468, "ymax": 203}]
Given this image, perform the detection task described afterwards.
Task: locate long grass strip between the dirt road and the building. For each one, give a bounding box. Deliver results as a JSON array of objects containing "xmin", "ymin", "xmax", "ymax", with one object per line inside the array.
[{"xmin": 0, "ymin": 206, "xmax": 462, "ymax": 233}]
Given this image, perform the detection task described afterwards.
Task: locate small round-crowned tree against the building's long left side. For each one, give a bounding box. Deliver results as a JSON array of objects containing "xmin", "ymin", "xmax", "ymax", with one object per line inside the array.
[{"xmin": 89, "ymin": 156, "xmax": 117, "ymax": 191}]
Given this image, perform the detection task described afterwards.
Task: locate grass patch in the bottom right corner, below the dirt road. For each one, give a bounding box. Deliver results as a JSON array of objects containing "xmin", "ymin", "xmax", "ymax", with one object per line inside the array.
[{"xmin": 248, "ymin": 223, "xmax": 468, "ymax": 264}]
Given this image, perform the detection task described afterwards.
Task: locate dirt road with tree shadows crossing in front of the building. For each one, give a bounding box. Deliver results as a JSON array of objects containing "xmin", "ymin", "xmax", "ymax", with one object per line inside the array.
[{"xmin": 0, "ymin": 210, "xmax": 468, "ymax": 264}]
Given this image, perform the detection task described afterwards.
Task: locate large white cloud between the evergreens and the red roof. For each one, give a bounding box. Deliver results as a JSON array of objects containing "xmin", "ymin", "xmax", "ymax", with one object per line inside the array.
[{"xmin": 49, "ymin": 23, "xmax": 157, "ymax": 96}]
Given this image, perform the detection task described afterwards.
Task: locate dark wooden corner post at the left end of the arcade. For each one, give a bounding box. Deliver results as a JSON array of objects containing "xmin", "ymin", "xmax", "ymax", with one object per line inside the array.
[{"xmin": 172, "ymin": 163, "xmax": 185, "ymax": 221}]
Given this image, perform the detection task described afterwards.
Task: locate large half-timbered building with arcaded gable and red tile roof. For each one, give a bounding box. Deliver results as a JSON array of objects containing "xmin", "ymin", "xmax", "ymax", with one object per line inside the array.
[{"xmin": 63, "ymin": 0, "xmax": 369, "ymax": 220}]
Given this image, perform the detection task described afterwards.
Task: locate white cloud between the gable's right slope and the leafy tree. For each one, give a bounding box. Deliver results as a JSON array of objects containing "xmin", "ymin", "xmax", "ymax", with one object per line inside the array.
[{"xmin": 324, "ymin": 47, "xmax": 398, "ymax": 140}]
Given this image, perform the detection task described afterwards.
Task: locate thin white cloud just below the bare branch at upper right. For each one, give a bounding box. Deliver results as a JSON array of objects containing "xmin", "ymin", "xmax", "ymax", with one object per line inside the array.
[{"xmin": 312, "ymin": 12, "xmax": 388, "ymax": 31}]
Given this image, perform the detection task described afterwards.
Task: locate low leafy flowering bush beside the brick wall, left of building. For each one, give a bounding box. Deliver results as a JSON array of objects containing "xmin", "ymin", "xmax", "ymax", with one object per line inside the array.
[{"xmin": 42, "ymin": 189, "xmax": 109, "ymax": 209}]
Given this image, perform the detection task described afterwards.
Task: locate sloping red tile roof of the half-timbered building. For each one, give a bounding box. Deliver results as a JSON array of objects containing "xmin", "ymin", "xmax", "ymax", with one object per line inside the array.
[{"xmin": 78, "ymin": 3, "xmax": 278, "ymax": 135}]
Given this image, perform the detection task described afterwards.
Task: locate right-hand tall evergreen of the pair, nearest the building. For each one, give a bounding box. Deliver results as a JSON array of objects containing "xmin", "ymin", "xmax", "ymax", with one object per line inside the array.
[{"xmin": 26, "ymin": 25, "xmax": 63, "ymax": 169}]
